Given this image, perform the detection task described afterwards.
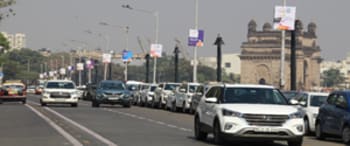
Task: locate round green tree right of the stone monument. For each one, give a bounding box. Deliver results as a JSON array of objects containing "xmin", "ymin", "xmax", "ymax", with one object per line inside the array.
[{"xmin": 322, "ymin": 68, "xmax": 345, "ymax": 87}]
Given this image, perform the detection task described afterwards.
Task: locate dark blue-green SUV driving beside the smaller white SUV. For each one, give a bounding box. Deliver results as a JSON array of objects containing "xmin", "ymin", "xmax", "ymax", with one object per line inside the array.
[{"xmin": 91, "ymin": 80, "xmax": 132, "ymax": 107}]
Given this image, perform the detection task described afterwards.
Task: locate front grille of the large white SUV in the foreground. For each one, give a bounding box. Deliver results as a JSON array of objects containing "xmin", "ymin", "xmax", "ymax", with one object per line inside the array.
[{"xmin": 243, "ymin": 114, "xmax": 289, "ymax": 126}]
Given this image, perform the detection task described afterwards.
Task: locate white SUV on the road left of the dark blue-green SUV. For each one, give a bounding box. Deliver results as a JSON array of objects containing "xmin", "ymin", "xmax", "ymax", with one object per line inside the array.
[{"xmin": 40, "ymin": 80, "xmax": 79, "ymax": 107}]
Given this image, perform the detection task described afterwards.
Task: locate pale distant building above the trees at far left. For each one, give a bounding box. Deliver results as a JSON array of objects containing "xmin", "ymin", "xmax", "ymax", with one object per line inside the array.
[{"xmin": 1, "ymin": 32, "xmax": 26, "ymax": 51}]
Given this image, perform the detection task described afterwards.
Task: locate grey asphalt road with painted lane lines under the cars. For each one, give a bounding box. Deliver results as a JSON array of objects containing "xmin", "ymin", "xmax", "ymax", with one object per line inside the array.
[{"xmin": 0, "ymin": 95, "xmax": 344, "ymax": 146}]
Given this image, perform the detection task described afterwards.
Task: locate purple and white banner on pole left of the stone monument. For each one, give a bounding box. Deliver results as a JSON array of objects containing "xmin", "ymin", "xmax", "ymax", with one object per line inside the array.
[{"xmin": 188, "ymin": 29, "xmax": 204, "ymax": 47}]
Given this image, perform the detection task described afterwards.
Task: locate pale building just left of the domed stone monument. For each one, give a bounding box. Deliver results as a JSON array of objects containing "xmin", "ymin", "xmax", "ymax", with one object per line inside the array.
[{"xmin": 198, "ymin": 54, "xmax": 241, "ymax": 75}]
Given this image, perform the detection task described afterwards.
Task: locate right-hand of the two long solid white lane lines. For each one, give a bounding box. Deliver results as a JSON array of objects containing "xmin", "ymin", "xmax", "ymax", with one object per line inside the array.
[{"xmin": 28, "ymin": 102, "xmax": 118, "ymax": 146}]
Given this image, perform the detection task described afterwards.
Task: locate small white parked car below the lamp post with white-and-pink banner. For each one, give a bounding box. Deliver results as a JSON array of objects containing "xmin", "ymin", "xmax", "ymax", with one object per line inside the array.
[{"xmin": 140, "ymin": 84, "xmax": 158, "ymax": 106}]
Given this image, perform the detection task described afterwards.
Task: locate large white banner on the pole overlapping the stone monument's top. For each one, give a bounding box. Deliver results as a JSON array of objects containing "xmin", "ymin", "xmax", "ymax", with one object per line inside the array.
[{"xmin": 273, "ymin": 6, "xmax": 296, "ymax": 30}]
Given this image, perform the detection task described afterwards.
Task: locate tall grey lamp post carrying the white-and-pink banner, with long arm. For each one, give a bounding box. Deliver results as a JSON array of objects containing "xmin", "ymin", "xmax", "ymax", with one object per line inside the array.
[{"xmin": 122, "ymin": 5, "xmax": 159, "ymax": 83}]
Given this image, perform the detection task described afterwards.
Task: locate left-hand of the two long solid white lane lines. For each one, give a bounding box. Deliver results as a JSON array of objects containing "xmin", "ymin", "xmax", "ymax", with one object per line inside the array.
[{"xmin": 25, "ymin": 104, "xmax": 83, "ymax": 146}]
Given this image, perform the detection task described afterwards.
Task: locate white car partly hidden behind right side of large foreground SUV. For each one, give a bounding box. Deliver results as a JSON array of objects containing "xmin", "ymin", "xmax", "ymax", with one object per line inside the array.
[{"xmin": 291, "ymin": 92, "xmax": 329, "ymax": 135}]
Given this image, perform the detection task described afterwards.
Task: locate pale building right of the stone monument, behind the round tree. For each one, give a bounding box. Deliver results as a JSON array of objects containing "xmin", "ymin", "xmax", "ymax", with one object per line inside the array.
[{"xmin": 320, "ymin": 52, "xmax": 350, "ymax": 88}]
